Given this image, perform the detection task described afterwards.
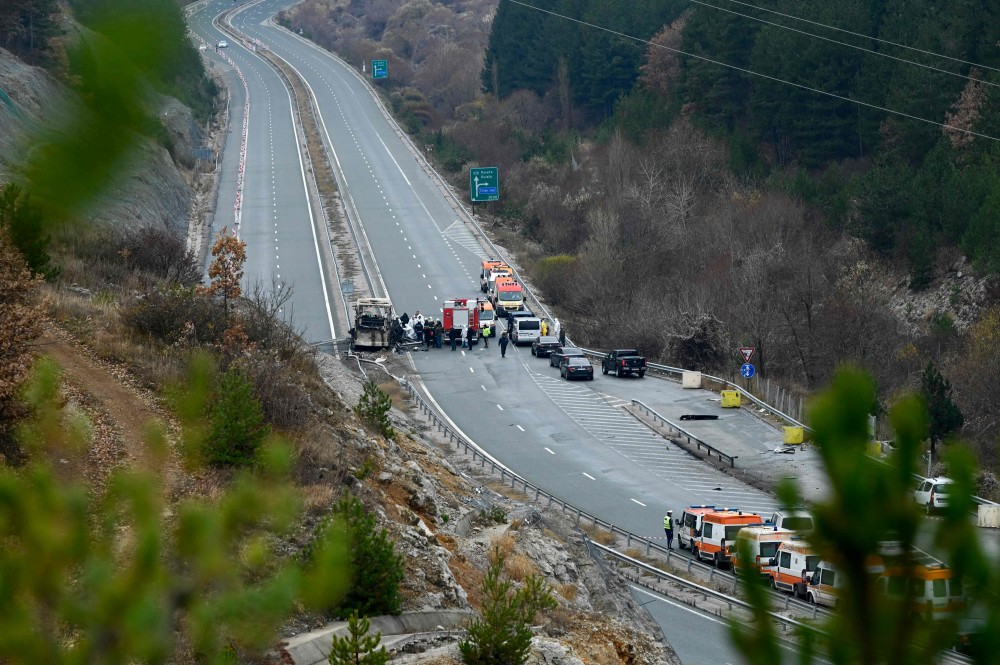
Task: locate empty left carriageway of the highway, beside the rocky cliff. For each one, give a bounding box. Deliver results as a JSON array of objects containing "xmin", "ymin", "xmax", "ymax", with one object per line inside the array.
[{"xmin": 188, "ymin": 3, "xmax": 339, "ymax": 341}]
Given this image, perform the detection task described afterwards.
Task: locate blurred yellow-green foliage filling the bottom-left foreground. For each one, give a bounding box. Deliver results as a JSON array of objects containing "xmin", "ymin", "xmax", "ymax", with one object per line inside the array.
[{"xmin": 0, "ymin": 363, "xmax": 346, "ymax": 665}]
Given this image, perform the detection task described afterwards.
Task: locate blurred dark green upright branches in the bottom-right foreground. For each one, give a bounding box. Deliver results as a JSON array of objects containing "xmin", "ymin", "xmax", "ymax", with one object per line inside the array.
[{"xmin": 732, "ymin": 370, "xmax": 1000, "ymax": 665}]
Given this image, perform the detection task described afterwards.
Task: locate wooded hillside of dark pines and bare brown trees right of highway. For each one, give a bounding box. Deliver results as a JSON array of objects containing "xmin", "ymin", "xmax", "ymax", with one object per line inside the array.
[{"xmin": 283, "ymin": 0, "xmax": 1000, "ymax": 464}]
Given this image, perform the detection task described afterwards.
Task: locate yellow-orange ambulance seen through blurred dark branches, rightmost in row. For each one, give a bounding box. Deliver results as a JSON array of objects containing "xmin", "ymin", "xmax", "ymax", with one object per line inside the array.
[{"xmin": 879, "ymin": 563, "xmax": 965, "ymax": 620}]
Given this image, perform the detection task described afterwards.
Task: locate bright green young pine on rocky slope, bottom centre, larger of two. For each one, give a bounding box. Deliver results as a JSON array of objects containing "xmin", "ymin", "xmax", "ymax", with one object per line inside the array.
[{"xmin": 458, "ymin": 550, "xmax": 556, "ymax": 665}]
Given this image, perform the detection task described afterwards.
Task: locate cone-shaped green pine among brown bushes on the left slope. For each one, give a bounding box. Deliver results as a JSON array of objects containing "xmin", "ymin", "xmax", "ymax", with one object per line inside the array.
[{"xmin": 205, "ymin": 366, "xmax": 269, "ymax": 466}]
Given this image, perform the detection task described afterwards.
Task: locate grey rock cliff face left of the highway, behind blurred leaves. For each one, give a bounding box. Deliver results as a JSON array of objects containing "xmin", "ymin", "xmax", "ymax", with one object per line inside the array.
[{"xmin": 0, "ymin": 49, "xmax": 204, "ymax": 233}]
